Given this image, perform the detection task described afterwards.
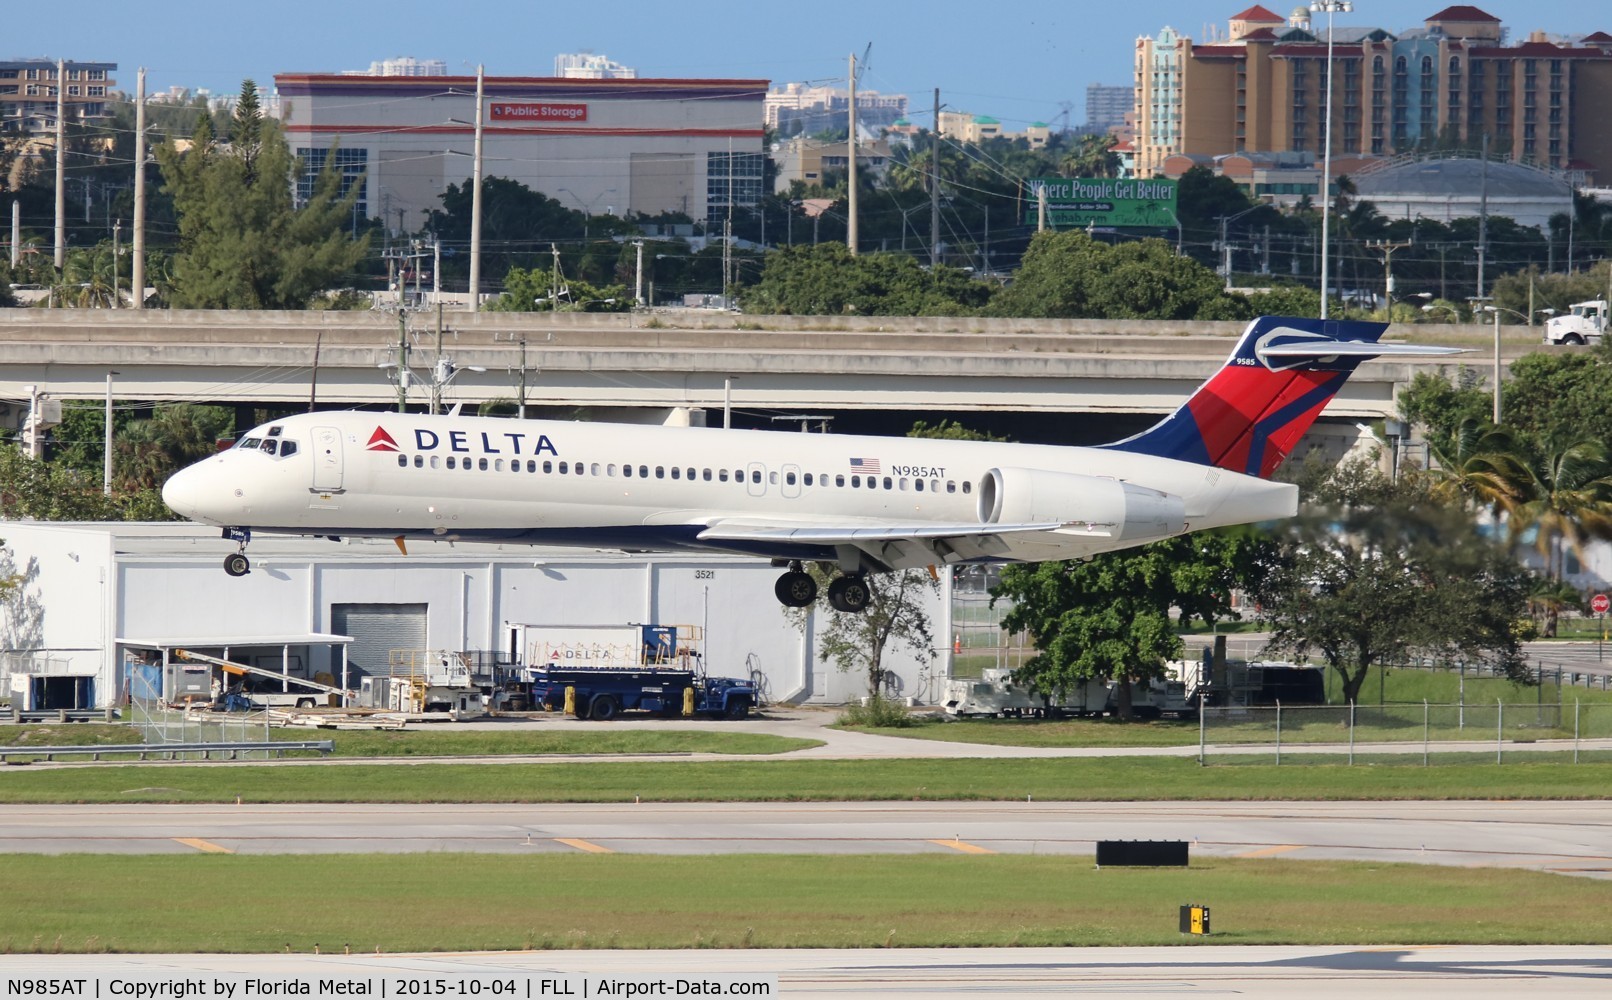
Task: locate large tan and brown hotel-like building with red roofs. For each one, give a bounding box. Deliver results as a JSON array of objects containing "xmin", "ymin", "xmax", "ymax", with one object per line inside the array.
[{"xmin": 1133, "ymin": 5, "xmax": 1612, "ymax": 181}]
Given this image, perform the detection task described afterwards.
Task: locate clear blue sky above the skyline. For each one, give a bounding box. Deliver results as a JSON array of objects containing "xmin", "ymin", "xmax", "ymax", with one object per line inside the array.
[{"xmin": 15, "ymin": 0, "xmax": 1612, "ymax": 126}]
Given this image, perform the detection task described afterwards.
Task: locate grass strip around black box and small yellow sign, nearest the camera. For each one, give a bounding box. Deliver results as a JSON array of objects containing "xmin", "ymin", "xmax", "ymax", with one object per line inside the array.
[{"xmin": 0, "ymin": 855, "xmax": 1612, "ymax": 953}]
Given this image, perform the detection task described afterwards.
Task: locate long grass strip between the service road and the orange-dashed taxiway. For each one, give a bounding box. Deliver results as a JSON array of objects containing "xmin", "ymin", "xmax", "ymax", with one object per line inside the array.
[{"xmin": 0, "ymin": 755, "xmax": 1612, "ymax": 803}]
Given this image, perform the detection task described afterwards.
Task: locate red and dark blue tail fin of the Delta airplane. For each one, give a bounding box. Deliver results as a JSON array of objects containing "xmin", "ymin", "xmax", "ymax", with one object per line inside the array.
[{"xmin": 1104, "ymin": 316, "xmax": 1460, "ymax": 477}]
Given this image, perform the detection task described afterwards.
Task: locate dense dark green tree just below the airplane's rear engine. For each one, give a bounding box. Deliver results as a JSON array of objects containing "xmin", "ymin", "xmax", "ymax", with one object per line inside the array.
[{"xmin": 991, "ymin": 531, "xmax": 1267, "ymax": 718}]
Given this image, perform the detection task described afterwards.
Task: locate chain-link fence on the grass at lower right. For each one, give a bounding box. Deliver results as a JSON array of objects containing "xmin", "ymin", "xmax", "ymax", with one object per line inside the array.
[{"xmin": 1199, "ymin": 700, "xmax": 1612, "ymax": 765}]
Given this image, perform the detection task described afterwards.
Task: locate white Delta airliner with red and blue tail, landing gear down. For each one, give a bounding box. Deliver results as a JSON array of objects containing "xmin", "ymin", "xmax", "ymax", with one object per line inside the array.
[{"xmin": 163, "ymin": 316, "xmax": 1459, "ymax": 611}]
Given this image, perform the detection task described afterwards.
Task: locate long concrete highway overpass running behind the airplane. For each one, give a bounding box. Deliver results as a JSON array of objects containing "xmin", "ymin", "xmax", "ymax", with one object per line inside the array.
[{"xmin": 0, "ymin": 308, "xmax": 1508, "ymax": 437}]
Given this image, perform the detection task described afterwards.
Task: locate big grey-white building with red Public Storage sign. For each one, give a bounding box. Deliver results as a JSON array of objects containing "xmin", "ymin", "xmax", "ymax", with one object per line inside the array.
[{"xmin": 274, "ymin": 73, "xmax": 767, "ymax": 235}]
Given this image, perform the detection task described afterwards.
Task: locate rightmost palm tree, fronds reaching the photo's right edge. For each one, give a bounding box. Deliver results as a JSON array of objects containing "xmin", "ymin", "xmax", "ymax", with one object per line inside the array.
[{"xmin": 1515, "ymin": 440, "xmax": 1612, "ymax": 581}]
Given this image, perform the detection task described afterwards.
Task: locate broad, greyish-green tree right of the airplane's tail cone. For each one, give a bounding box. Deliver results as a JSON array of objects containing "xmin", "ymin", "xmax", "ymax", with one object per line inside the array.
[{"xmin": 1253, "ymin": 463, "xmax": 1531, "ymax": 702}]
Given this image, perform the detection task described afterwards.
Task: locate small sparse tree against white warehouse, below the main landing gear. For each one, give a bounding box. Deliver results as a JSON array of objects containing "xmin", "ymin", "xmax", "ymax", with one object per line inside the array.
[{"xmin": 783, "ymin": 566, "xmax": 940, "ymax": 698}]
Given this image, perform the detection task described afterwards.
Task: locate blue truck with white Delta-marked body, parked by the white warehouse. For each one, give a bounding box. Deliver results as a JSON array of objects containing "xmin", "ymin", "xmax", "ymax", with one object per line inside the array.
[{"xmin": 511, "ymin": 624, "xmax": 758, "ymax": 721}]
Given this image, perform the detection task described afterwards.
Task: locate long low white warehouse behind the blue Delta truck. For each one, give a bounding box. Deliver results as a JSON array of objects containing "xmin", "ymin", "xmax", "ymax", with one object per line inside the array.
[{"xmin": 0, "ymin": 521, "xmax": 951, "ymax": 708}]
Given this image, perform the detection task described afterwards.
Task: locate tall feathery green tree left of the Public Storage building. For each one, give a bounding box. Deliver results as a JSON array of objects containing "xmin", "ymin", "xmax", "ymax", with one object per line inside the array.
[{"xmin": 156, "ymin": 81, "xmax": 368, "ymax": 310}]
